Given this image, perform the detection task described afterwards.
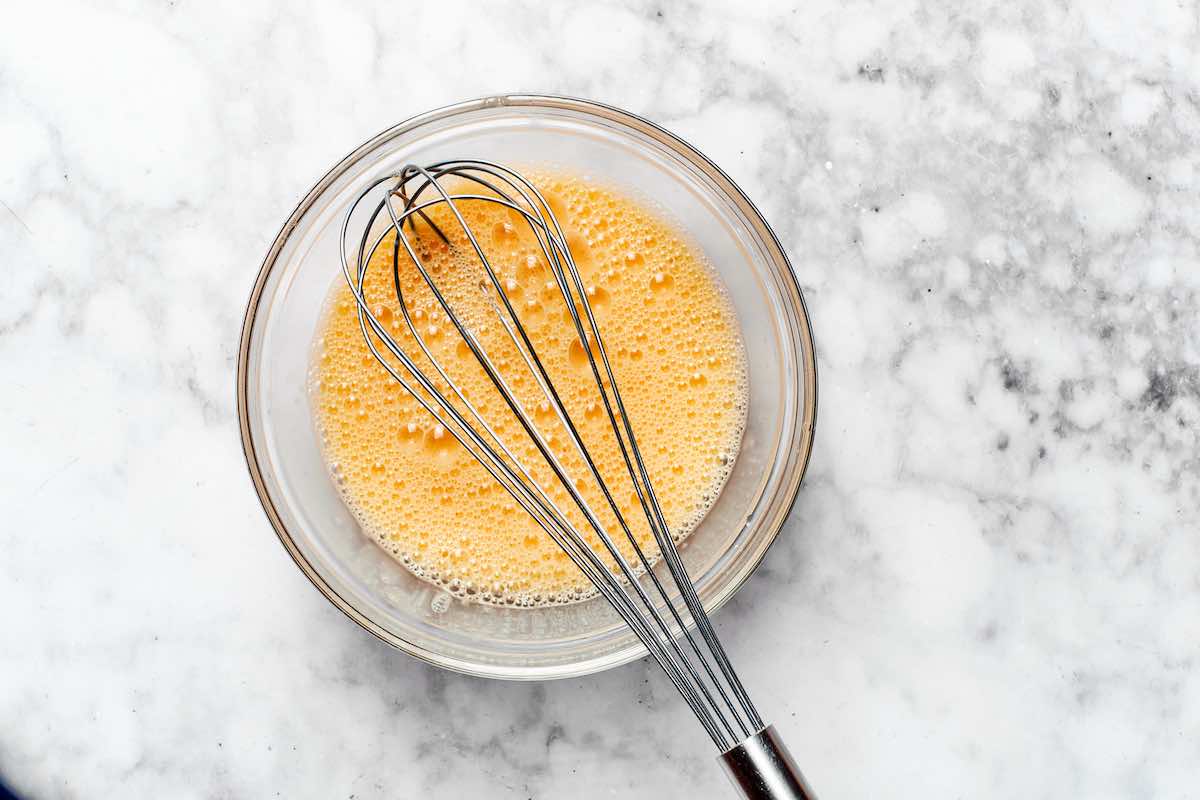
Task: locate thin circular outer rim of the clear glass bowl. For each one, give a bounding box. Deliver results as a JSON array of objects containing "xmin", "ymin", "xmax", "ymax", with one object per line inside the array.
[{"xmin": 235, "ymin": 94, "xmax": 817, "ymax": 680}]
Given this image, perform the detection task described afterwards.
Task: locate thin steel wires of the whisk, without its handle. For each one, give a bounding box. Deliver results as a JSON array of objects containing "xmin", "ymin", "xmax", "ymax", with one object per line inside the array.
[{"xmin": 341, "ymin": 161, "xmax": 763, "ymax": 751}]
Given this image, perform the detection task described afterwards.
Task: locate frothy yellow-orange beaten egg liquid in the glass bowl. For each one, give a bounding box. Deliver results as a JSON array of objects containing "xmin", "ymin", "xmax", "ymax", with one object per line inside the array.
[{"xmin": 310, "ymin": 172, "xmax": 746, "ymax": 607}]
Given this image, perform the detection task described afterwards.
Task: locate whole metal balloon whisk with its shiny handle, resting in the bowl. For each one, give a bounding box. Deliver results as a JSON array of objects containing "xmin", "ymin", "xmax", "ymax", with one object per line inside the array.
[{"xmin": 341, "ymin": 160, "xmax": 814, "ymax": 800}]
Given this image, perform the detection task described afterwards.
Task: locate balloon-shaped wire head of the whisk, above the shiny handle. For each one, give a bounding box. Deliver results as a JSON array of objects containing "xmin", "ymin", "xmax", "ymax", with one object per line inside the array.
[{"xmin": 341, "ymin": 160, "xmax": 764, "ymax": 752}]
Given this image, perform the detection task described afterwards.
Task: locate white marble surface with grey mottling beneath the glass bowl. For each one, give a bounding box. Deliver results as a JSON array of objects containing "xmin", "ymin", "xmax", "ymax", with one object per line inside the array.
[{"xmin": 0, "ymin": 0, "xmax": 1200, "ymax": 800}]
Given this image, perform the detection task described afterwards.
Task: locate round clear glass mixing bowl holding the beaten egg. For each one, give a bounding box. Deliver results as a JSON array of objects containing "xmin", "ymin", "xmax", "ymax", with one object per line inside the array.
[{"xmin": 238, "ymin": 95, "xmax": 816, "ymax": 679}]
